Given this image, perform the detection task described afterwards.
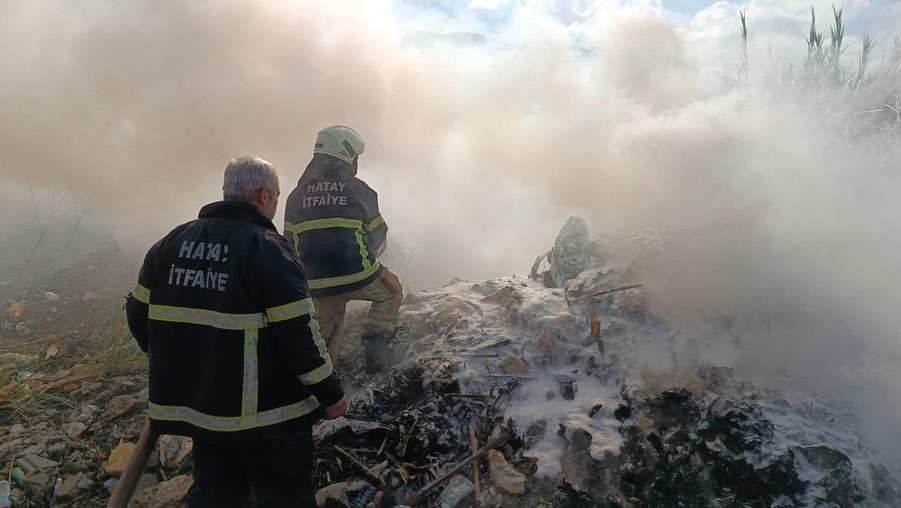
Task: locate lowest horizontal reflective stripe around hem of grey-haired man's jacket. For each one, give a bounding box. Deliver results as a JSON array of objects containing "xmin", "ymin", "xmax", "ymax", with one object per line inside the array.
[{"xmin": 148, "ymin": 396, "xmax": 319, "ymax": 432}]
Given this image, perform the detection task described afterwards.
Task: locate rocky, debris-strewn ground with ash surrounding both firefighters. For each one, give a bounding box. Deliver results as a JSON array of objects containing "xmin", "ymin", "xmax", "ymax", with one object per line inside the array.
[{"xmin": 0, "ymin": 221, "xmax": 901, "ymax": 507}]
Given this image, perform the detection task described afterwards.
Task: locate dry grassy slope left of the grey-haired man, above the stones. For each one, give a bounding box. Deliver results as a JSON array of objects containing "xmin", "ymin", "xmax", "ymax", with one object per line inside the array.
[{"xmin": 0, "ymin": 250, "xmax": 146, "ymax": 421}]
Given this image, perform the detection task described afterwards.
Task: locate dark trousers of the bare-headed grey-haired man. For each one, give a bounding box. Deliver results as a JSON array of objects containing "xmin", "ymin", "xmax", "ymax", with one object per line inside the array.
[{"xmin": 188, "ymin": 432, "xmax": 316, "ymax": 508}]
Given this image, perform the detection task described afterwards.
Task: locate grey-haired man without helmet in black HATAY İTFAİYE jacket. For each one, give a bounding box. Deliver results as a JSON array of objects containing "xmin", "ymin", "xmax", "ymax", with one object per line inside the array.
[{"xmin": 126, "ymin": 156, "xmax": 347, "ymax": 507}]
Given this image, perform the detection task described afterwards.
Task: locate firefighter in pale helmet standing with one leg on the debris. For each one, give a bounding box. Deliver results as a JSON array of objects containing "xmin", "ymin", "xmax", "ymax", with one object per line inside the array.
[{"xmin": 284, "ymin": 125, "xmax": 403, "ymax": 374}]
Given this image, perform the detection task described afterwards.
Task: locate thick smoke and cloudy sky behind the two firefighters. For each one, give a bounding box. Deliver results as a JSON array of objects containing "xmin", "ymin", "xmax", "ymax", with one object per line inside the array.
[{"xmin": 0, "ymin": 0, "xmax": 901, "ymax": 456}]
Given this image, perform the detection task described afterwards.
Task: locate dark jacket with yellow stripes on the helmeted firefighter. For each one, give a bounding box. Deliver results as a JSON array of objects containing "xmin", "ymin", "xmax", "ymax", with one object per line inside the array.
[{"xmin": 285, "ymin": 154, "xmax": 388, "ymax": 296}]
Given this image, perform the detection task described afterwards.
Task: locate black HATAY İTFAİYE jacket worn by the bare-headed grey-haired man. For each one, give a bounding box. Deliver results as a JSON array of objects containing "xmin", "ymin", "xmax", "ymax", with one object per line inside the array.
[{"xmin": 126, "ymin": 201, "xmax": 343, "ymax": 443}]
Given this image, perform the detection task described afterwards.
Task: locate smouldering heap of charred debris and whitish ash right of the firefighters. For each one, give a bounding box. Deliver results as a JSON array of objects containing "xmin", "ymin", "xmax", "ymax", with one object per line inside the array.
[{"xmin": 318, "ymin": 218, "xmax": 901, "ymax": 507}]
